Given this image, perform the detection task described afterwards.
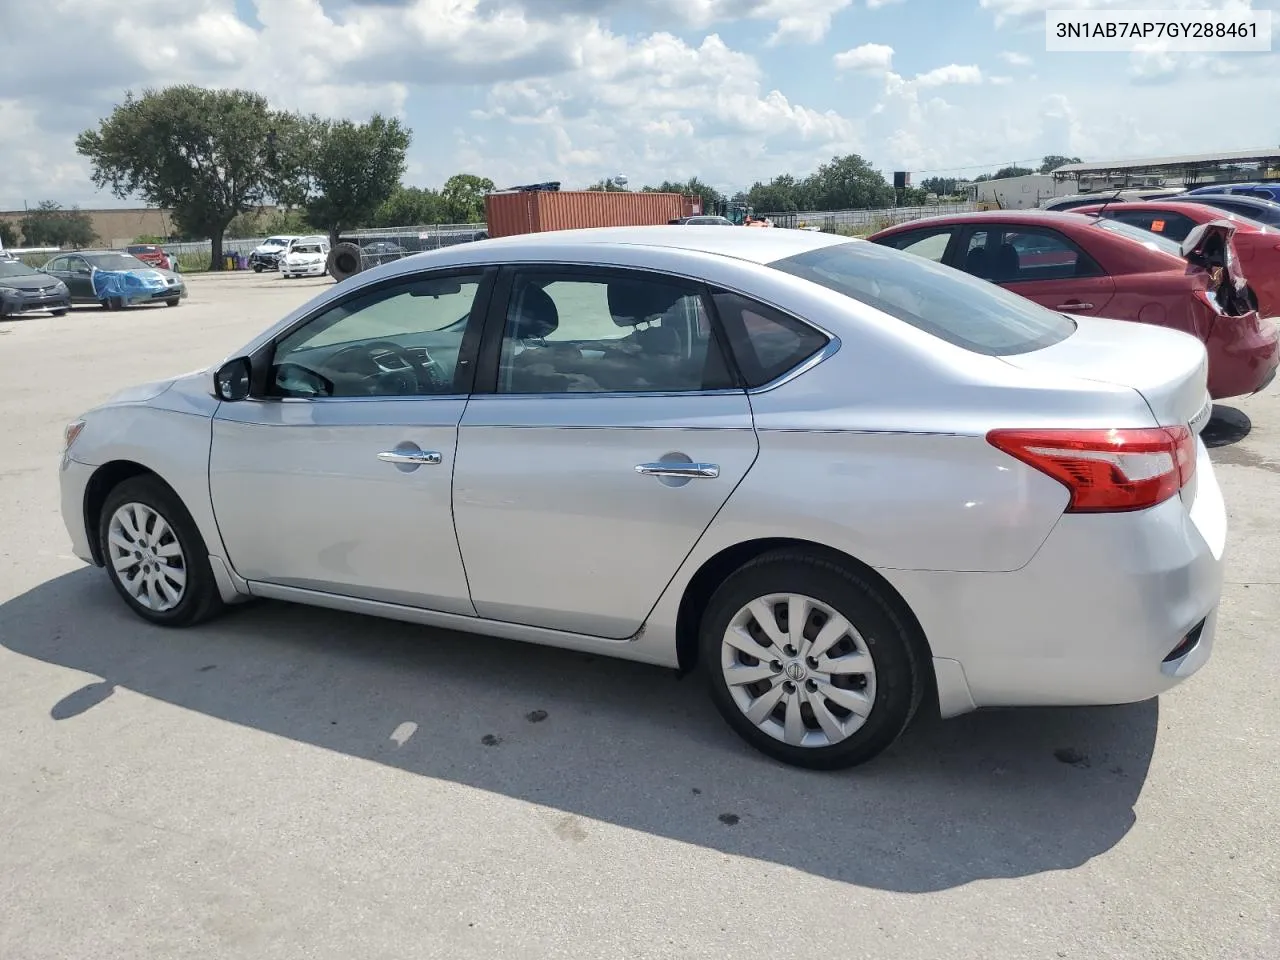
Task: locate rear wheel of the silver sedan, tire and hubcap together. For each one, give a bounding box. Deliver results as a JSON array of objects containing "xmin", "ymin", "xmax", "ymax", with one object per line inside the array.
[{"xmin": 700, "ymin": 550, "xmax": 924, "ymax": 769}]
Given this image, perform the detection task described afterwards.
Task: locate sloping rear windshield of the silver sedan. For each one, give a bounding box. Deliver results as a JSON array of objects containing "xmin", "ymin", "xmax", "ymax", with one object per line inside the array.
[{"xmin": 769, "ymin": 241, "xmax": 1075, "ymax": 357}]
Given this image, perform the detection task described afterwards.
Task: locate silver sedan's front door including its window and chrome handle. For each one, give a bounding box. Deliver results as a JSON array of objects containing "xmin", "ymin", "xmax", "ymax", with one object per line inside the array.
[{"xmin": 209, "ymin": 271, "xmax": 492, "ymax": 614}]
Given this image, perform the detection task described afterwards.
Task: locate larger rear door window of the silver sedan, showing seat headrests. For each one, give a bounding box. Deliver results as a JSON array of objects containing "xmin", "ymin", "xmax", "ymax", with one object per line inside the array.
[{"xmin": 498, "ymin": 273, "xmax": 733, "ymax": 394}]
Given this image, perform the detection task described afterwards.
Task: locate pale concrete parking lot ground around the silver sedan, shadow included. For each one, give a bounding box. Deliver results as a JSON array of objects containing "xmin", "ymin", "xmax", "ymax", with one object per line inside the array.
[{"xmin": 0, "ymin": 273, "xmax": 1280, "ymax": 960}]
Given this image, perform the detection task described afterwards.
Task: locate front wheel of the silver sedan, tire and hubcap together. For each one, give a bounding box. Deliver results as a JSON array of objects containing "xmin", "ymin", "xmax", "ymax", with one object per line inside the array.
[{"xmin": 97, "ymin": 476, "xmax": 223, "ymax": 627}]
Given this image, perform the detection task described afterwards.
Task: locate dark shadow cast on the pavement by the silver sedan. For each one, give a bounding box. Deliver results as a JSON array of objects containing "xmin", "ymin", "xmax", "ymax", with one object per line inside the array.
[{"xmin": 0, "ymin": 568, "xmax": 1158, "ymax": 892}]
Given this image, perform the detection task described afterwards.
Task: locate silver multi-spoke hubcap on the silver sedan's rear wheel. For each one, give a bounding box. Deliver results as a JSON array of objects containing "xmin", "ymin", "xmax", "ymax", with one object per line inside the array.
[{"xmin": 721, "ymin": 594, "xmax": 876, "ymax": 748}]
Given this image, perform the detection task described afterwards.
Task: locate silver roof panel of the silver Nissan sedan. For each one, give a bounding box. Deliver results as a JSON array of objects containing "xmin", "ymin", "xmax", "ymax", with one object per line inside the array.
[{"xmin": 435, "ymin": 224, "xmax": 849, "ymax": 264}]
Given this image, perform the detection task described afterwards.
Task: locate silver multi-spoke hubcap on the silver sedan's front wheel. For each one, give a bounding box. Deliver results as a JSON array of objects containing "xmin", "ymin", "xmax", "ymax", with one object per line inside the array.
[{"xmin": 106, "ymin": 503, "xmax": 187, "ymax": 613}]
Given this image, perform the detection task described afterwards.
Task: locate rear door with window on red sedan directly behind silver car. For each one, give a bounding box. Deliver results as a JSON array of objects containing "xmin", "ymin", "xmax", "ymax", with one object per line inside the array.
[{"xmin": 952, "ymin": 224, "xmax": 1115, "ymax": 316}]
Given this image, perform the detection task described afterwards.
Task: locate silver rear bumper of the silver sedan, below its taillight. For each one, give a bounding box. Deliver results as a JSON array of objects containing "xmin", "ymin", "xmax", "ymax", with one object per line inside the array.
[{"xmin": 881, "ymin": 444, "xmax": 1226, "ymax": 713}]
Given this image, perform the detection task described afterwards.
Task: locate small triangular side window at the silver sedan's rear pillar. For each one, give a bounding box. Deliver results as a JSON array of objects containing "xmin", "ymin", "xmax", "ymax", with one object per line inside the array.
[{"xmin": 714, "ymin": 293, "xmax": 828, "ymax": 388}]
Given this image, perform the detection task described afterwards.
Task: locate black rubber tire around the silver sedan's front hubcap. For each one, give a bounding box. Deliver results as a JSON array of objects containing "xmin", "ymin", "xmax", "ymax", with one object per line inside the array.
[{"xmin": 97, "ymin": 475, "xmax": 224, "ymax": 627}]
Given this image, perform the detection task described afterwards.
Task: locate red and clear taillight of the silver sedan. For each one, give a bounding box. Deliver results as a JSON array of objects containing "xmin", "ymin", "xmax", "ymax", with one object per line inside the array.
[{"xmin": 987, "ymin": 426, "xmax": 1196, "ymax": 513}]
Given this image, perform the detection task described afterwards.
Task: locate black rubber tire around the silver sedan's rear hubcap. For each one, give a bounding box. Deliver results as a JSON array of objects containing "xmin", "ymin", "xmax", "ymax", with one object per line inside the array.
[{"xmin": 699, "ymin": 549, "xmax": 925, "ymax": 771}]
